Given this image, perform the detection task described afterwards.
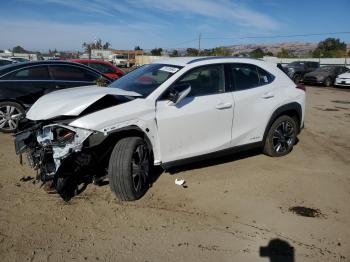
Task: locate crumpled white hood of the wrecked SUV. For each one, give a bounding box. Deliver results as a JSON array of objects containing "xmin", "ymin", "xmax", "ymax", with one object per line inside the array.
[{"xmin": 26, "ymin": 86, "xmax": 141, "ymax": 120}]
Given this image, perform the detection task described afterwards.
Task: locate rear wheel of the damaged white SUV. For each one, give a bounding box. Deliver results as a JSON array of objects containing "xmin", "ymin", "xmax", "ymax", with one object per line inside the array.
[{"xmin": 263, "ymin": 115, "xmax": 298, "ymax": 157}]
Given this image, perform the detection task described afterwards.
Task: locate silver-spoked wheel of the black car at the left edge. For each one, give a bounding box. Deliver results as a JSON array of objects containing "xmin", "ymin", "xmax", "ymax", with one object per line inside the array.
[{"xmin": 0, "ymin": 101, "xmax": 24, "ymax": 133}]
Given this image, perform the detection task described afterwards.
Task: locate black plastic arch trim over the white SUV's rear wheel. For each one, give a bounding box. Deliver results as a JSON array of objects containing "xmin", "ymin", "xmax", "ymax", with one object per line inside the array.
[{"xmin": 263, "ymin": 102, "xmax": 302, "ymax": 141}]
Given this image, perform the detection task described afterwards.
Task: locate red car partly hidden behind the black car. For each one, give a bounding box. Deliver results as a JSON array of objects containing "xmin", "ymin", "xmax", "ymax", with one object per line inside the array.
[{"xmin": 70, "ymin": 59, "xmax": 125, "ymax": 79}]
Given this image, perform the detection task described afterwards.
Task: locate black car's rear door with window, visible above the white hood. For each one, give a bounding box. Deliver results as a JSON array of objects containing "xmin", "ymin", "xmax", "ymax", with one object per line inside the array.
[{"xmin": 49, "ymin": 65, "xmax": 104, "ymax": 89}]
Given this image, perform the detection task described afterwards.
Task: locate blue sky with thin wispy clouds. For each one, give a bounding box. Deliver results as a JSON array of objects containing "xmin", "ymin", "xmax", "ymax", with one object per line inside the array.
[{"xmin": 0, "ymin": 0, "xmax": 350, "ymax": 51}]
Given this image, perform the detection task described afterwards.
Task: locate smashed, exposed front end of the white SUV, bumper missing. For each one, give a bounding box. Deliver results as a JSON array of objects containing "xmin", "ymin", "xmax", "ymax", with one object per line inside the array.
[{"xmin": 15, "ymin": 122, "xmax": 108, "ymax": 201}]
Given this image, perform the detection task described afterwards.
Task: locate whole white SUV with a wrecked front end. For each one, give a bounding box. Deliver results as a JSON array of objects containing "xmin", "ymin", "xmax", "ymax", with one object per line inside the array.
[{"xmin": 15, "ymin": 57, "xmax": 305, "ymax": 200}]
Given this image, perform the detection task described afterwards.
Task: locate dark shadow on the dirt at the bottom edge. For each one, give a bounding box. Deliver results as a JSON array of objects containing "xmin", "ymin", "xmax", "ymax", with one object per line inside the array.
[{"xmin": 259, "ymin": 238, "xmax": 295, "ymax": 262}]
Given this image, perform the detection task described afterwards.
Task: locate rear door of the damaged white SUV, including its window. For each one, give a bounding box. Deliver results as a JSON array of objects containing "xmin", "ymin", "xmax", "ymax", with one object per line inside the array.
[{"xmin": 229, "ymin": 63, "xmax": 281, "ymax": 146}]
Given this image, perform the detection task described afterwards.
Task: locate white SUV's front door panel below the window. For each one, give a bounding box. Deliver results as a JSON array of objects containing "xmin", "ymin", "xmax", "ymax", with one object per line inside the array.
[{"xmin": 156, "ymin": 93, "xmax": 233, "ymax": 162}]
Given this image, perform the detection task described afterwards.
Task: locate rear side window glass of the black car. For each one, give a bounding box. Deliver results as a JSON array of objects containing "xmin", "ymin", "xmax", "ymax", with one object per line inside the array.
[{"xmin": 50, "ymin": 65, "xmax": 99, "ymax": 82}]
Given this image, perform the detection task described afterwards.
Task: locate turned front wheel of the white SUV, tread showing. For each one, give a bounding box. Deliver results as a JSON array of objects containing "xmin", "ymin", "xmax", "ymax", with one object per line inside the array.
[{"xmin": 108, "ymin": 137, "xmax": 151, "ymax": 201}]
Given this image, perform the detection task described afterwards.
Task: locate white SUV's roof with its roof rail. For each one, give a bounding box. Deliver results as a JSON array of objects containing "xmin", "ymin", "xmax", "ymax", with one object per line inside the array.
[{"xmin": 153, "ymin": 56, "xmax": 261, "ymax": 66}]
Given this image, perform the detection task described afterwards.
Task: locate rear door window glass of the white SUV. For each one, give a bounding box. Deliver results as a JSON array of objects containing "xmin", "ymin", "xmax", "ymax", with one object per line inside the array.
[{"xmin": 231, "ymin": 64, "xmax": 264, "ymax": 91}]
